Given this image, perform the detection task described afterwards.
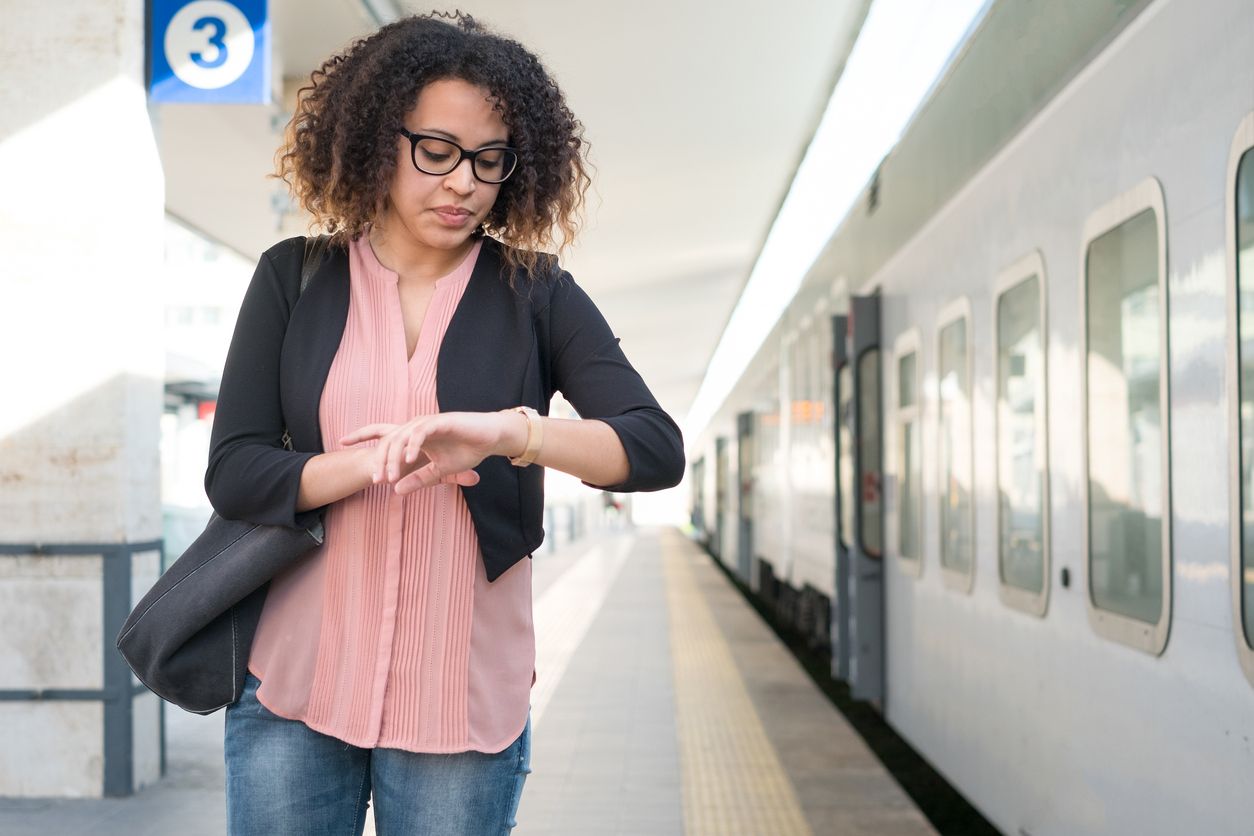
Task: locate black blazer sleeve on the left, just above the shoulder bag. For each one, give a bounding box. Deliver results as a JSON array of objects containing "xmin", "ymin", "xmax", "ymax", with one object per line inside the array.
[{"xmin": 204, "ymin": 245, "xmax": 317, "ymax": 528}]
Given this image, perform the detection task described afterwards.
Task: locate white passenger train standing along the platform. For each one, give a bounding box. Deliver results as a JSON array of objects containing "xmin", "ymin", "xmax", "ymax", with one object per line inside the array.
[{"xmin": 691, "ymin": 0, "xmax": 1254, "ymax": 836}]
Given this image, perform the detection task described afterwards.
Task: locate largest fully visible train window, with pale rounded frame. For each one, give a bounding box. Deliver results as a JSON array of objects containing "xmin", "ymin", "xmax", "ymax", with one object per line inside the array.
[{"xmin": 1083, "ymin": 180, "xmax": 1171, "ymax": 653}]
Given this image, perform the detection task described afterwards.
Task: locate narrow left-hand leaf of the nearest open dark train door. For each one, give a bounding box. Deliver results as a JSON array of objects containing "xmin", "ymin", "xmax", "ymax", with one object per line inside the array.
[{"xmin": 831, "ymin": 316, "xmax": 854, "ymax": 682}]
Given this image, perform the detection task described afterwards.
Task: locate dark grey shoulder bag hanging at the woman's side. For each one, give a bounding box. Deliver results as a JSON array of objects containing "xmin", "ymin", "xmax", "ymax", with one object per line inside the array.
[{"xmin": 117, "ymin": 236, "xmax": 329, "ymax": 714}]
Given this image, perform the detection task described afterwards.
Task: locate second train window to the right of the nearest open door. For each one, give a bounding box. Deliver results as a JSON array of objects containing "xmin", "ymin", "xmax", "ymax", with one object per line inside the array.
[{"xmin": 937, "ymin": 300, "xmax": 976, "ymax": 592}]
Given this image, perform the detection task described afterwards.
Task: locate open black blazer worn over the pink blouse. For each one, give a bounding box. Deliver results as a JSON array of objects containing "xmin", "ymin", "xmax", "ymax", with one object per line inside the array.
[{"xmin": 204, "ymin": 238, "xmax": 683, "ymax": 580}]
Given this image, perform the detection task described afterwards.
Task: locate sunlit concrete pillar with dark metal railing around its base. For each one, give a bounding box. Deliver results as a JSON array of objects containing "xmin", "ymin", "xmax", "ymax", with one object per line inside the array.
[{"xmin": 0, "ymin": 0, "xmax": 164, "ymax": 797}]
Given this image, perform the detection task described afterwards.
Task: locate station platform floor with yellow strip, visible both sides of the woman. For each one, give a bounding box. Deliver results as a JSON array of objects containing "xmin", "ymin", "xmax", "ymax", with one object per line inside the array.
[{"xmin": 0, "ymin": 528, "xmax": 935, "ymax": 836}]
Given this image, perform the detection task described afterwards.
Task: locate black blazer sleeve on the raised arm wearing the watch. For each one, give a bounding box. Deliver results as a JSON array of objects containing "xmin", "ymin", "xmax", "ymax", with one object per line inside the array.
[{"xmin": 548, "ymin": 271, "xmax": 685, "ymax": 493}]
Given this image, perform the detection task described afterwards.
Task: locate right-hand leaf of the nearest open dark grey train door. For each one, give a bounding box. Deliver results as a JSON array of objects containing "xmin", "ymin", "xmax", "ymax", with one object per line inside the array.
[{"xmin": 836, "ymin": 296, "xmax": 884, "ymax": 702}]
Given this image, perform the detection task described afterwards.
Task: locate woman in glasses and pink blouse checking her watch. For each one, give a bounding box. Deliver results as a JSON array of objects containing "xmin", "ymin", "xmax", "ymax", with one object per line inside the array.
[{"xmin": 206, "ymin": 9, "xmax": 683, "ymax": 836}]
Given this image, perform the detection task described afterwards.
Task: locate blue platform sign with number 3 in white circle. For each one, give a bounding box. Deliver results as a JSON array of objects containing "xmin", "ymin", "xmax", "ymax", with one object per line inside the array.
[{"xmin": 148, "ymin": 0, "xmax": 270, "ymax": 104}]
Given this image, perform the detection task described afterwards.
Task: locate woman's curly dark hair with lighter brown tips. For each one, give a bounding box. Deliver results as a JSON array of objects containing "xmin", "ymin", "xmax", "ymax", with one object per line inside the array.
[{"xmin": 273, "ymin": 11, "xmax": 591, "ymax": 277}]
